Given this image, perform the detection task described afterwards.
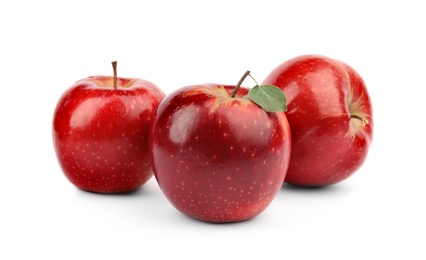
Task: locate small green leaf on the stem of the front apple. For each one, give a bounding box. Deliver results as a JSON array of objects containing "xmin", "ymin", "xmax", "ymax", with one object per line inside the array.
[{"xmin": 249, "ymin": 85, "xmax": 287, "ymax": 112}]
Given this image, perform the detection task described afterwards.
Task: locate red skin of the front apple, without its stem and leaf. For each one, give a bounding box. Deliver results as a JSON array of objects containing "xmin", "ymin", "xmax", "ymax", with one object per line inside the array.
[{"xmin": 150, "ymin": 84, "xmax": 291, "ymax": 223}]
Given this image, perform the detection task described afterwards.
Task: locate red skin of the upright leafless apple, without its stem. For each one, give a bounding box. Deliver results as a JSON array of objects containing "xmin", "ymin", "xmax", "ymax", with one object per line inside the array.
[{"xmin": 52, "ymin": 76, "xmax": 165, "ymax": 193}]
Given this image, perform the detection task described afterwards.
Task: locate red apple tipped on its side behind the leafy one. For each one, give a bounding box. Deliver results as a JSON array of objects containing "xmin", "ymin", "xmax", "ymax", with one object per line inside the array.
[{"xmin": 263, "ymin": 55, "xmax": 373, "ymax": 186}]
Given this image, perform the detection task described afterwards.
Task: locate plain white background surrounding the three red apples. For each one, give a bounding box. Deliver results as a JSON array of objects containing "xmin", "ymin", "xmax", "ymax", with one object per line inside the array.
[{"xmin": 0, "ymin": 0, "xmax": 426, "ymax": 259}]
